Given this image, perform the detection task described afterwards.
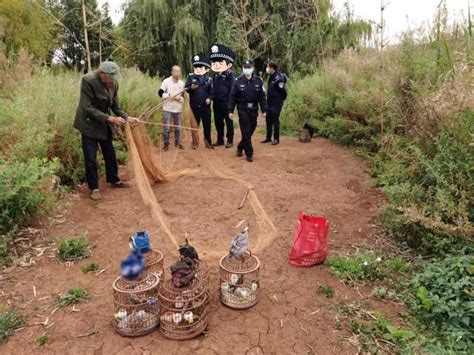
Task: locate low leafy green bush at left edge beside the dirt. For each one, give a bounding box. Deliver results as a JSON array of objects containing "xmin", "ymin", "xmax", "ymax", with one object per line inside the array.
[{"xmin": 0, "ymin": 158, "xmax": 59, "ymax": 236}]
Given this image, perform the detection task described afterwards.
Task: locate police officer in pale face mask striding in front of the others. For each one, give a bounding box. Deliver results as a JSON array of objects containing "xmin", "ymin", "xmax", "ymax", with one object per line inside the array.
[{"xmin": 229, "ymin": 59, "xmax": 267, "ymax": 162}]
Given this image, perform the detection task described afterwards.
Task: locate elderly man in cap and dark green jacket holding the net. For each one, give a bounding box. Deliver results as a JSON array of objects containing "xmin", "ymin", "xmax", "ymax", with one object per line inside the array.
[{"xmin": 74, "ymin": 62, "xmax": 138, "ymax": 201}]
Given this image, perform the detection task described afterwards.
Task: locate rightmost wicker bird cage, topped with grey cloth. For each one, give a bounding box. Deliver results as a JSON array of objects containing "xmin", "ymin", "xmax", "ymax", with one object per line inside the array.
[{"xmin": 219, "ymin": 253, "xmax": 260, "ymax": 309}]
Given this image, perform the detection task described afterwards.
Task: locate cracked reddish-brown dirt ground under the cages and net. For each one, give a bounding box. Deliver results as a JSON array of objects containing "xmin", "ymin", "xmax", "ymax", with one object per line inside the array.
[{"xmin": 0, "ymin": 134, "xmax": 397, "ymax": 354}]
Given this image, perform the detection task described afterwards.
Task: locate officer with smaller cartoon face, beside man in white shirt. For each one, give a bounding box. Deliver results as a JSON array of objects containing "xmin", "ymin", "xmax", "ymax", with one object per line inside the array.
[{"xmin": 185, "ymin": 55, "xmax": 213, "ymax": 148}]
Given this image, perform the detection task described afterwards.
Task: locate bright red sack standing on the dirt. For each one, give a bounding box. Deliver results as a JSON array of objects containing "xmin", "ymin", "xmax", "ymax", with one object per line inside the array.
[{"xmin": 288, "ymin": 212, "xmax": 329, "ymax": 266}]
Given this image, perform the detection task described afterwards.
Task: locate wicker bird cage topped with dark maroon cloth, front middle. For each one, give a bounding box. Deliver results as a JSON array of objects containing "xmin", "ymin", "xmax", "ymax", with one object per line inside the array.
[{"xmin": 159, "ymin": 277, "xmax": 208, "ymax": 340}]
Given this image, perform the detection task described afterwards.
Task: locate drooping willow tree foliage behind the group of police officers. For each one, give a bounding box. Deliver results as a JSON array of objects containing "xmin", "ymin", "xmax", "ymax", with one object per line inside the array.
[{"xmin": 120, "ymin": 0, "xmax": 372, "ymax": 75}]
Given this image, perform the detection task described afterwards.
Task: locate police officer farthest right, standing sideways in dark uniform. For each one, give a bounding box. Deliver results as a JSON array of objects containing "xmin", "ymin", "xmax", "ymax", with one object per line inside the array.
[{"xmin": 262, "ymin": 61, "xmax": 288, "ymax": 145}]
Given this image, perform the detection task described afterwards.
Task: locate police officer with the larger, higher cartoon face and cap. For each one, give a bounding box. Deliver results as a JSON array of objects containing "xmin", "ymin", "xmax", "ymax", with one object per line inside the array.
[{"xmin": 209, "ymin": 44, "xmax": 235, "ymax": 148}]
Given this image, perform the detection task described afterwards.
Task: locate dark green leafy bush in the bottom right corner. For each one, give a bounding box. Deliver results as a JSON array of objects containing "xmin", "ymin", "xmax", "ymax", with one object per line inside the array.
[{"xmin": 407, "ymin": 255, "xmax": 474, "ymax": 351}]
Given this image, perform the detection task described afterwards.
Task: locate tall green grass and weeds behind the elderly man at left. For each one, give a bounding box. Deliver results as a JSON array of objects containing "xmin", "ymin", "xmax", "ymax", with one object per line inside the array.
[{"xmin": 0, "ymin": 68, "xmax": 159, "ymax": 250}]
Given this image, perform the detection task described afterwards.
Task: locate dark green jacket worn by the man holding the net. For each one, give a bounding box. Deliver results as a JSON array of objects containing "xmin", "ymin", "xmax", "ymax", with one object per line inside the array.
[{"xmin": 74, "ymin": 72, "xmax": 128, "ymax": 140}]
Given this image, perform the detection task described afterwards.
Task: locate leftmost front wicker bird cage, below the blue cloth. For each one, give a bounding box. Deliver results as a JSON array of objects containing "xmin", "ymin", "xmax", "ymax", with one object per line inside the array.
[{"xmin": 113, "ymin": 273, "xmax": 160, "ymax": 337}]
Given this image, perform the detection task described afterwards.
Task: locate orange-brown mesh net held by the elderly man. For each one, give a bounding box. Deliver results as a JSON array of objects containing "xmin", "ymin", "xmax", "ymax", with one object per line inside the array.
[{"xmin": 125, "ymin": 96, "xmax": 277, "ymax": 257}]
